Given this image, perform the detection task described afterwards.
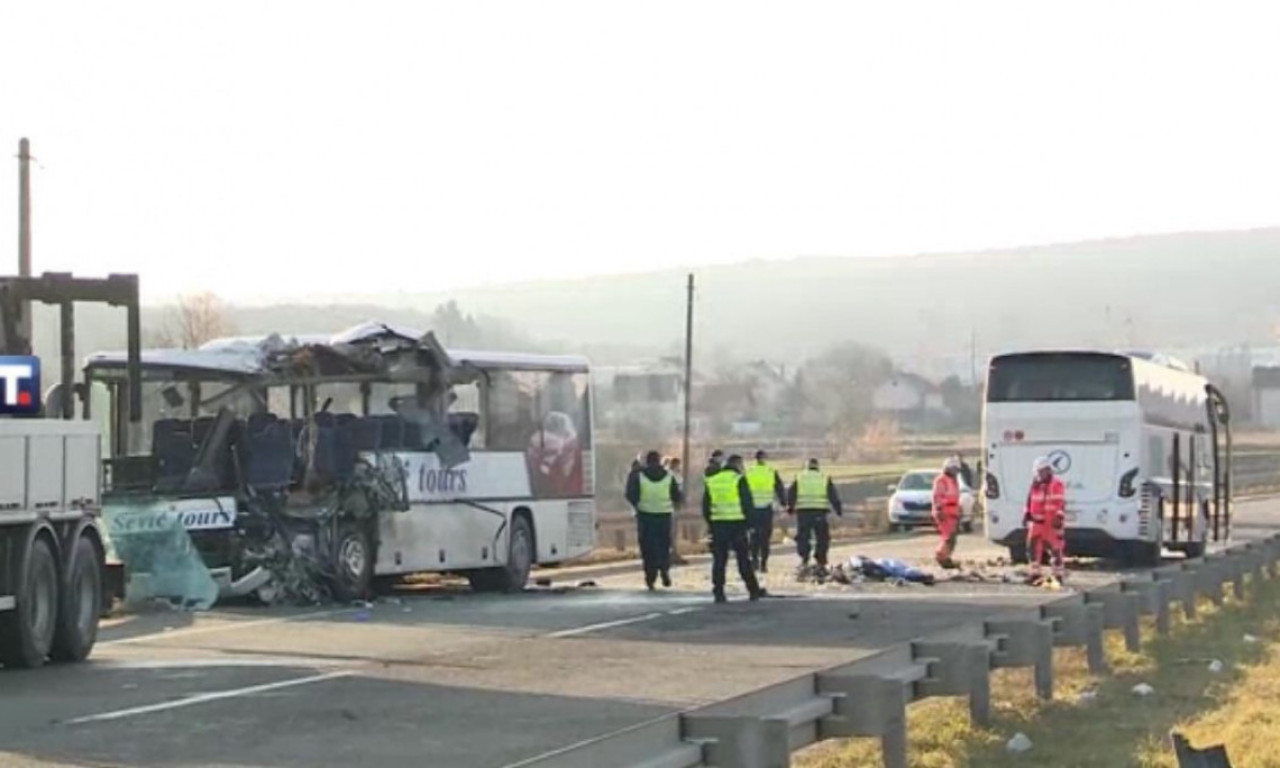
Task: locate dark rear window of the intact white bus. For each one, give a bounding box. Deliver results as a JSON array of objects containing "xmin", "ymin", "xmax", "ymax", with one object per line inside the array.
[{"xmin": 987, "ymin": 355, "xmax": 1134, "ymax": 403}]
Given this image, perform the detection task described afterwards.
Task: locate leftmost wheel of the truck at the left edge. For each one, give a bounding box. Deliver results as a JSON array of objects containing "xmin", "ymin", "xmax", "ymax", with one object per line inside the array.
[{"xmin": 0, "ymin": 538, "xmax": 60, "ymax": 668}]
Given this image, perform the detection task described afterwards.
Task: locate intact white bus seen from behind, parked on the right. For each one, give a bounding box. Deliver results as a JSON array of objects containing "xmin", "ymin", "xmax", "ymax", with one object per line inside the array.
[{"xmin": 982, "ymin": 351, "xmax": 1231, "ymax": 564}]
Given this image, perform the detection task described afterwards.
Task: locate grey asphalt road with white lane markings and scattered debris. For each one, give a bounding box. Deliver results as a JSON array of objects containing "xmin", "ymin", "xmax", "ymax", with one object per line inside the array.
[{"xmin": 0, "ymin": 502, "xmax": 1280, "ymax": 768}]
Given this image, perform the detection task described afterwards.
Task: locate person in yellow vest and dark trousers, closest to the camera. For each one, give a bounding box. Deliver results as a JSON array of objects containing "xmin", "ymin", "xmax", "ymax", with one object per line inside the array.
[{"xmin": 703, "ymin": 454, "xmax": 764, "ymax": 603}]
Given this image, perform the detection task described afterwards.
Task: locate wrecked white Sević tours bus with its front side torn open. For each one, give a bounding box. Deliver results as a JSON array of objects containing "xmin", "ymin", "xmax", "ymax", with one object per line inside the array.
[{"xmin": 86, "ymin": 323, "xmax": 595, "ymax": 608}]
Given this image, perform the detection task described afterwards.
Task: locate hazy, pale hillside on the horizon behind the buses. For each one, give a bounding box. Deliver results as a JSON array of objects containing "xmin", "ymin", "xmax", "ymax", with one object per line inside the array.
[{"xmin": 27, "ymin": 228, "xmax": 1280, "ymax": 375}]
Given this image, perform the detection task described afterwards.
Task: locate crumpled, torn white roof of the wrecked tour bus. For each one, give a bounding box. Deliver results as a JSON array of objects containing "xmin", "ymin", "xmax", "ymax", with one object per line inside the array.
[{"xmin": 84, "ymin": 321, "xmax": 590, "ymax": 376}]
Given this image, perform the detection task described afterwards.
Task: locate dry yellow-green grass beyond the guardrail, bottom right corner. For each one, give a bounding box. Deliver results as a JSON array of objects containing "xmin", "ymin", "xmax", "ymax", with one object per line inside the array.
[{"xmin": 794, "ymin": 570, "xmax": 1280, "ymax": 768}]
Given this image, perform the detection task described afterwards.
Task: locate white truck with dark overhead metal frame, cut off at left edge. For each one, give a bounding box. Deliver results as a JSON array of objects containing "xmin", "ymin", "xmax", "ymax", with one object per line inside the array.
[{"xmin": 0, "ymin": 273, "xmax": 141, "ymax": 668}]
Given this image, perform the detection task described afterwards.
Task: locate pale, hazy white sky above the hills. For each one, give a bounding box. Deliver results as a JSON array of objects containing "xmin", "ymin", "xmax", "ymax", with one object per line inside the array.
[{"xmin": 0, "ymin": 0, "xmax": 1280, "ymax": 300}]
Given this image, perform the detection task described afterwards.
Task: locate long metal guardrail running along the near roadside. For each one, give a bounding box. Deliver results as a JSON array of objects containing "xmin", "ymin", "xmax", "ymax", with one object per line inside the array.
[{"xmin": 508, "ymin": 534, "xmax": 1280, "ymax": 768}]
